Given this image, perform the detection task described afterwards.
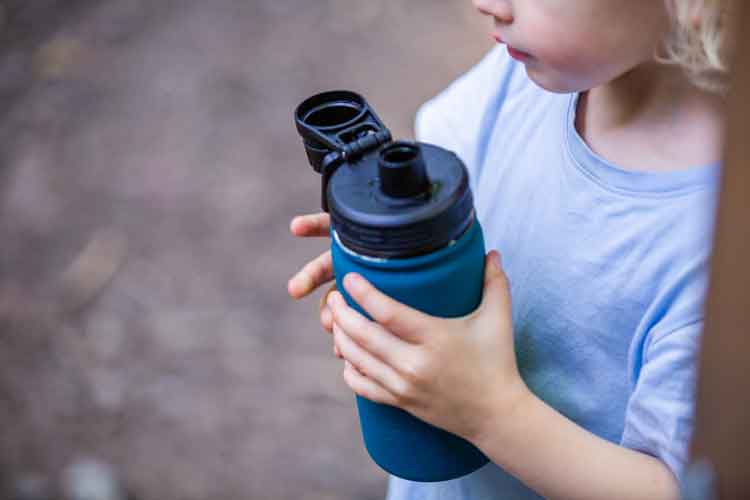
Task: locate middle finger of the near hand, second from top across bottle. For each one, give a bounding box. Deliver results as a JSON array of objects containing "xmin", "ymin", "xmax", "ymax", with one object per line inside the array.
[{"xmin": 328, "ymin": 292, "xmax": 411, "ymax": 368}]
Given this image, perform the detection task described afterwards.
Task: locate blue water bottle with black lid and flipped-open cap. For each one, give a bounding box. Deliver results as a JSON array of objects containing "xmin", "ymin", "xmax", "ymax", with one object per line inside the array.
[{"xmin": 295, "ymin": 90, "xmax": 488, "ymax": 482}]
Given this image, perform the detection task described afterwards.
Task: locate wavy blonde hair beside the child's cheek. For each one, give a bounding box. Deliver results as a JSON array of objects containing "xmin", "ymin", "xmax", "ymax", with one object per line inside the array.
[{"xmin": 657, "ymin": 0, "xmax": 733, "ymax": 93}]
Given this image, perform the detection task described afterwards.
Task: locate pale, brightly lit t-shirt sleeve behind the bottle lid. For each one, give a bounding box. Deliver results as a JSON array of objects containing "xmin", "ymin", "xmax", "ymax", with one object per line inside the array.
[{"xmin": 414, "ymin": 46, "xmax": 509, "ymax": 176}]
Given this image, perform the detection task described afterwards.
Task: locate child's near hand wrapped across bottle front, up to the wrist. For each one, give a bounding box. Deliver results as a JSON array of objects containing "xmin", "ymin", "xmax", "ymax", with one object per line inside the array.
[{"xmin": 328, "ymin": 252, "xmax": 530, "ymax": 441}]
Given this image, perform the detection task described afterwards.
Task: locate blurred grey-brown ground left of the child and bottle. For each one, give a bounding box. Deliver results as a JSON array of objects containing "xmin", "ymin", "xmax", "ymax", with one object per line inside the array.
[{"xmin": 0, "ymin": 0, "xmax": 494, "ymax": 500}]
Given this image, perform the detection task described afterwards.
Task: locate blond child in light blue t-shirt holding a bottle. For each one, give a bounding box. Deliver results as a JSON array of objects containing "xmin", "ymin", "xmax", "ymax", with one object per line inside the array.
[{"xmin": 289, "ymin": 0, "xmax": 728, "ymax": 500}]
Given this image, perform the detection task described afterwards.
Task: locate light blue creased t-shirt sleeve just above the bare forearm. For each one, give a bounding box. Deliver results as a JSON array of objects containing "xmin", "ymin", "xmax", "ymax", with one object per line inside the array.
[{"xmin": 621, "ymin": 320, "xmax": 703, "ymax": 478}]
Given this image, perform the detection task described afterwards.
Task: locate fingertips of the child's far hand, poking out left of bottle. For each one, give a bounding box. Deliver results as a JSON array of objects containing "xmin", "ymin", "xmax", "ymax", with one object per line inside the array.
[{"xmin": 287, "ymin": 212, "xmax": 341, "ymax": 357}]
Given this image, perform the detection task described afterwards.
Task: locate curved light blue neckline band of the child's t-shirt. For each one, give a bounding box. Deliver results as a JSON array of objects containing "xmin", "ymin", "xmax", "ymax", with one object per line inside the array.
[{"xmin": 565, "ymin": 93, "xmax": 721, "ymax": 196}]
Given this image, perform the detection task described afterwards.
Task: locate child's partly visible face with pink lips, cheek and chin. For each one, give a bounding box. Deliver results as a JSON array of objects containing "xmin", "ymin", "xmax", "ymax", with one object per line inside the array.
[{"xmin": 473, "ymin": 0, "xmax": 669, "ymax": 92}]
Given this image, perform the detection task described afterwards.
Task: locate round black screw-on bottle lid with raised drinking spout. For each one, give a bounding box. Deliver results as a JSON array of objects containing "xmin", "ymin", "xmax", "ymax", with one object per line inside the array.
[{"xmin": 326, "ymin": 141, "xmax": 474, "ymax": 258}]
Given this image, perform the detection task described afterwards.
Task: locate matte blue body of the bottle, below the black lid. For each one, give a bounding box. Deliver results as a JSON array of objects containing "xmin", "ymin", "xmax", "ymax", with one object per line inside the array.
[{"xmin": 331, "ymin": 219, "xmax": 489, "ymax": 482}]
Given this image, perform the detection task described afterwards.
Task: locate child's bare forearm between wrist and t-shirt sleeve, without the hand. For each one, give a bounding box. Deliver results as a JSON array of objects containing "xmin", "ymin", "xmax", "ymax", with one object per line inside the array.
[{"xmin": 474, "ymin": 384, "xmax": 679, "ymax": 500}]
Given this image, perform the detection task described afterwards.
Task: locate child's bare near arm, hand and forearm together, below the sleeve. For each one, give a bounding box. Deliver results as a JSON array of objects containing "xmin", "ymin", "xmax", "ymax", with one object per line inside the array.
[{"xmin": 328, "ymin": 252, "xmax": 678, "ymax": 500}]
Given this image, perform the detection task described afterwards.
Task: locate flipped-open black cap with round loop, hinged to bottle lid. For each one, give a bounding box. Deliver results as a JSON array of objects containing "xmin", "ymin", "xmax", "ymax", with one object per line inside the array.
[{"xmin": 294, "ymin": 90, "xmax": 391, "ymax": 212}]
